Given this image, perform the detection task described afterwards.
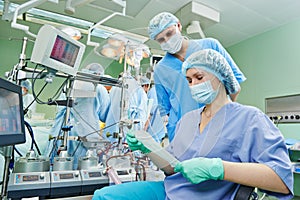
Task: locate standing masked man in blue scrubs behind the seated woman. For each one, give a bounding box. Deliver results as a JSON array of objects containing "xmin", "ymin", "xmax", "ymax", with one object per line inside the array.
[{"xmin": 148, "ymin": 12, "xmax": 246, "ymax": 140}]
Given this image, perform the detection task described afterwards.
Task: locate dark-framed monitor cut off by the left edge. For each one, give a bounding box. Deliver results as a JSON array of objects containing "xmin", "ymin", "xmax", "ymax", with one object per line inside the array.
[{"xmin": 0, "ymin": 78, "xmax": 26, "ymax": 146}]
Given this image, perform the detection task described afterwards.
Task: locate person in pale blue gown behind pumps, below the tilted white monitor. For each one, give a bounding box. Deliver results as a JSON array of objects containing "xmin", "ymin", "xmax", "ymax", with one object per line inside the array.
[{"xmin": 47, "ymin": 63, "xmax": 110, "ymax": 169}]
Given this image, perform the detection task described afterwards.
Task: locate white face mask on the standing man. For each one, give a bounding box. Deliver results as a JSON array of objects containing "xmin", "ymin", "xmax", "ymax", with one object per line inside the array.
[{"xmin": 160, "ymin": 26, "xmax": 183, "ymax": 54}]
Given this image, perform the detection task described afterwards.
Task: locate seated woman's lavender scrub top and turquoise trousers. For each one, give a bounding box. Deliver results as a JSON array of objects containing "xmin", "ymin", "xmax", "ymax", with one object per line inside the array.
[{"xmin": 93, "ymin": 103, "xmax": 293, "ymax": 200}]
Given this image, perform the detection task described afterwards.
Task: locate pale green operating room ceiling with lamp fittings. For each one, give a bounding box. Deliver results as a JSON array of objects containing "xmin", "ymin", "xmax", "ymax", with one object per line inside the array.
[{"xmin": 2, "ymin": 0, "xmax": 300, "ymax": 47}]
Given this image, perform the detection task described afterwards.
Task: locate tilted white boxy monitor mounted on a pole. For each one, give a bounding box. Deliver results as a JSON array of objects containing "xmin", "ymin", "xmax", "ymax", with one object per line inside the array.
[{"xmin": 31, "ymin": 24, "xmax": 85, "ymax": 76}]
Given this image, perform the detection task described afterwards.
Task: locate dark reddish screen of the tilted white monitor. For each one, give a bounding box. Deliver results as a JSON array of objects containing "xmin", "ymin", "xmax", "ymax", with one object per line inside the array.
[{"xmin": 50, "ymin": 35, "xmax": 79, "ymax": 67}]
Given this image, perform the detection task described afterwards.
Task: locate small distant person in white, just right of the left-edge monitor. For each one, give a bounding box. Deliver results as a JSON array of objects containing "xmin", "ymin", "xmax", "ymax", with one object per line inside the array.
[{"xmin": 21, "ymin": 79, "xmax": 36, "ymax": 119}]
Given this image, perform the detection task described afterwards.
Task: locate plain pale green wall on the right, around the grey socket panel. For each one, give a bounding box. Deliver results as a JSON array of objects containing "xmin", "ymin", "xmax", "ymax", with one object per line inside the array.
[{"xmin": 227, "ymin": 20, "xmax": 300, "ymax": 139}]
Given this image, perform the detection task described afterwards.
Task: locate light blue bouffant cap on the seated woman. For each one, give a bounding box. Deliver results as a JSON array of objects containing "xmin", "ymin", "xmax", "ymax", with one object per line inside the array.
[{"xmin": 182, "ymin": 49, "xmax": 240, "ymax": 94}]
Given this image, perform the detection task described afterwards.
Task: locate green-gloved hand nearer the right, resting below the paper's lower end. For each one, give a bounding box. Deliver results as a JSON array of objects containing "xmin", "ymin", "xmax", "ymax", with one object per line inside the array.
[{"xmin": 174, "ymin": 157, "xmax": 224, "ymax": 184}]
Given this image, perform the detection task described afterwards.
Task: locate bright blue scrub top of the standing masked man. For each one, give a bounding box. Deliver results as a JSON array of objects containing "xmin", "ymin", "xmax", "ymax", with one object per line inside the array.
[{"xmin": 154, "ymin": 38, "xmax": 246, "ymax": 141}]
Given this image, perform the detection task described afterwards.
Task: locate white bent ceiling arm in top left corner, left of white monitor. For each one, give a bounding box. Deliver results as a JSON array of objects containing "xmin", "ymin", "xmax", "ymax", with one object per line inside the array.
[{"xmin": 11, "ymin": 0, "xmax": 48, "ymax": 38}]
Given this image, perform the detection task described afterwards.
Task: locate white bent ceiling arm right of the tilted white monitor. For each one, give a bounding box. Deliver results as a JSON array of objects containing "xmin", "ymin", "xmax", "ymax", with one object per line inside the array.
[{"xmin": 86, "ymin": 0, "xmax": 126, "ymax": 47}]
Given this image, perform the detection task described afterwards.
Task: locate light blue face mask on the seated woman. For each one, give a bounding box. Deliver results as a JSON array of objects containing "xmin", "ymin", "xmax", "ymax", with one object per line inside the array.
[{"xmin": 190, "ymin": 80, "xmax": 220, "ymax": 104}]
